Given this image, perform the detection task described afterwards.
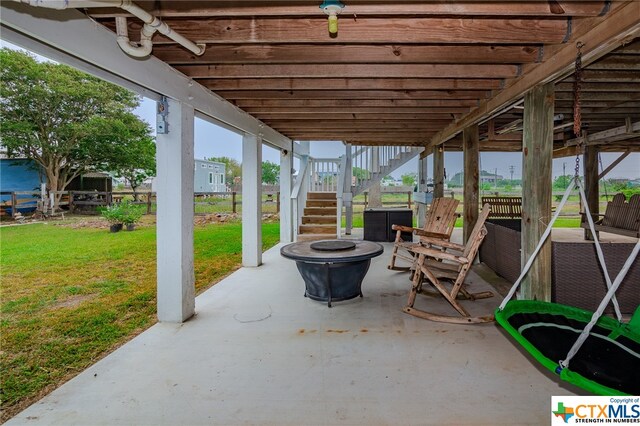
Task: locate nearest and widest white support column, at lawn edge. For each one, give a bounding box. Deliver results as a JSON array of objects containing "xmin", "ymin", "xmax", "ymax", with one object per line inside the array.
[{"xmin": 156, "ymin": 100, "xmax": 195, "ymax": 322}]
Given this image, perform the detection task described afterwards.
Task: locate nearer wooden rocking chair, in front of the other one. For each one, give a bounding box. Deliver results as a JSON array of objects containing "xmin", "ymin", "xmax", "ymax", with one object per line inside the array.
[{"xmin": 403, "ymin": 204, "xmax": 493, "ymax": 324}]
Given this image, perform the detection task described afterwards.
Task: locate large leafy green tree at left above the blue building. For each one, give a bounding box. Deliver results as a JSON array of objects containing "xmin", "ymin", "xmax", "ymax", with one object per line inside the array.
[{"xmin": 0, "ymin": 48, "xmax": 149, "ymax": 204}]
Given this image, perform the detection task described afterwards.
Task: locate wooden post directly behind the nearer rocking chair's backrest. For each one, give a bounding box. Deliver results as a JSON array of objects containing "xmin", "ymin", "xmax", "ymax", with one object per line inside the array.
[{"xmin": 462, "ymin": 125, "xmax": 480, "ymax": 244}]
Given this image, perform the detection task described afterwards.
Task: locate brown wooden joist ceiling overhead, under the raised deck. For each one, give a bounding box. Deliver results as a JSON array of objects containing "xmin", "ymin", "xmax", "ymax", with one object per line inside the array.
[{"xmin": 87, "ymin": 0, "xmax": 640, "ymax": 151}]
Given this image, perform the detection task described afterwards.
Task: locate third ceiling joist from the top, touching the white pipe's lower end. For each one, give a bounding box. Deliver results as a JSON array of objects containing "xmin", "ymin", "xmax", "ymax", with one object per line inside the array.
[{"xmin": 153, "ymin": 44, "xmax": 542, "ymax": 65}]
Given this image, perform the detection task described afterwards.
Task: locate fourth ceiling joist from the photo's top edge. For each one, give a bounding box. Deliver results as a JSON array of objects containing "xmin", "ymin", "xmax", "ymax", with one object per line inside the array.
[{"xmin": 175, "ymin": 64, "xmax": 519, "ymax": 79}]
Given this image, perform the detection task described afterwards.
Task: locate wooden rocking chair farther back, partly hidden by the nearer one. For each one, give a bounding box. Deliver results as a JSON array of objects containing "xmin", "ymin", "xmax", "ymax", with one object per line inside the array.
[{"xmin": 387, "ymin": 198, "xmax": 459, "ymax": 271}]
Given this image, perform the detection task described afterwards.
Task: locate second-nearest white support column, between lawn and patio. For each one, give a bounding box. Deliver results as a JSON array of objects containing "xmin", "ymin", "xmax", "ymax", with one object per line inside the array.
[{"xmin": 242, "ymin": 133, "xmax": 262, "ymax": 266}]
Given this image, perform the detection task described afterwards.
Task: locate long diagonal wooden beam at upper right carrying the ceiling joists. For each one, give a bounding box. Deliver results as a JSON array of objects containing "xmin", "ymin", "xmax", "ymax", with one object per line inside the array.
[{"xmin": 430, "ymin": 1, "xmax": 640, "ymax": 146}]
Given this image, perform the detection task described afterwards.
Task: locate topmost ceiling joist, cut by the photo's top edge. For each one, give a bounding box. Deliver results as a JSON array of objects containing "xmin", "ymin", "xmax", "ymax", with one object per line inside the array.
[{"xmin": 90, "ymin": 0, "xmax": 607, "ymax": 18}]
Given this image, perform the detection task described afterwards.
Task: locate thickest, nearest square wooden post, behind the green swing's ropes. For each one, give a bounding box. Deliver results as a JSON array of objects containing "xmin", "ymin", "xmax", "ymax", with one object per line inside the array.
[{"xmin": 518, "ymin": 83, "xmax": 555, "ymax": 301}]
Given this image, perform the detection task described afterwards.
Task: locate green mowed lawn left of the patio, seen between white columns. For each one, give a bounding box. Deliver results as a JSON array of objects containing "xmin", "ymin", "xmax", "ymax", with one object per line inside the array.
[{"xmin": 0, "ymin": 223, "xmax": 279, "ymax": 422}]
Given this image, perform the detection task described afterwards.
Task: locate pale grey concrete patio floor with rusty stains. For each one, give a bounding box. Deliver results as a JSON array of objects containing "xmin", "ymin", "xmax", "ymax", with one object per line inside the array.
[{"xmin": 7, "ymin": 233, "xmax": 584, "ymax": 425}]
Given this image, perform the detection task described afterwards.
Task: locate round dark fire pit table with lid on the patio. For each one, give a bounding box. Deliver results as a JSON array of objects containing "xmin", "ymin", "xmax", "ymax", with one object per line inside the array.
[{"xmin": 280, "ymin": 240, "xmax": 384, "ymax": 307}]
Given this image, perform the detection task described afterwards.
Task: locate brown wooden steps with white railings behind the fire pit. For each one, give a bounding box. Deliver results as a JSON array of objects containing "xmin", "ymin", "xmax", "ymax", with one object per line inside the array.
[{"xmin": 298, "ymin": 192, "xmax": 338, "ymax": 241}]
